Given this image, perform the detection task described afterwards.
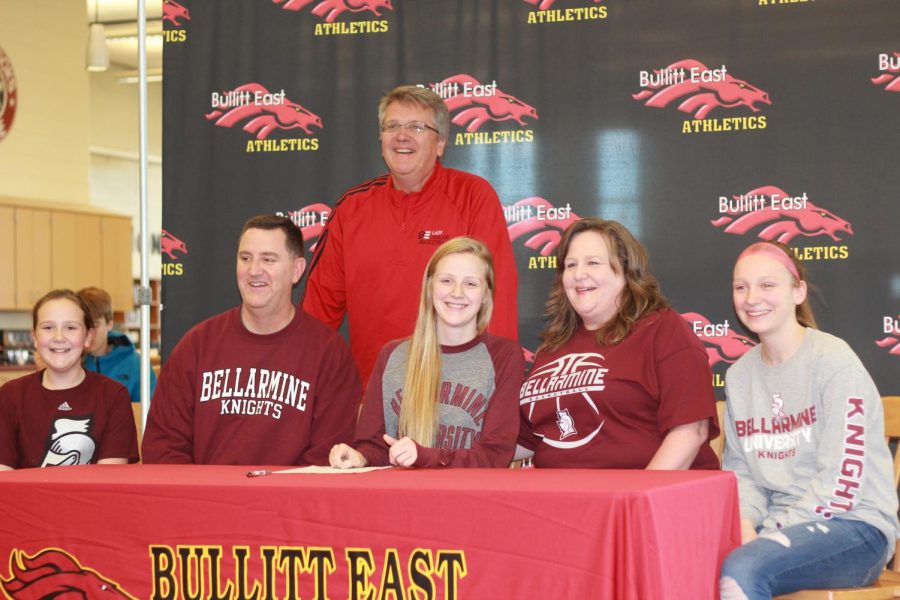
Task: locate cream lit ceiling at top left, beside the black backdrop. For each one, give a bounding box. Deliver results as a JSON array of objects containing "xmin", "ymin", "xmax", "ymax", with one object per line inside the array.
[{"xmin": 85, "ymin": 0, "xmax": 163, "ymax": 77}]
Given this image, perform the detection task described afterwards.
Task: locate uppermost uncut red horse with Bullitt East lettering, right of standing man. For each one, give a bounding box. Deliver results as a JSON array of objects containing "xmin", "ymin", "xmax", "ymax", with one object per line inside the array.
[{"xmin": 631, "ymin": 58, "xmax": 772, "ymax": 119}]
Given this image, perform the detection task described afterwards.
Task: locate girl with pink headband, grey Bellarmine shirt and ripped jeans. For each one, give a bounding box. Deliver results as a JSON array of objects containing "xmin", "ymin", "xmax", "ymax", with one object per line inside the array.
[{"xmin": 720, "ymin": 242, "xmax": 900, "ymax": 600}]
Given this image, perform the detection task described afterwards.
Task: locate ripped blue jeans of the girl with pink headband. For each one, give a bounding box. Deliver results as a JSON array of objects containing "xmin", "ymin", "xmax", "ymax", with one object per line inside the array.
[{"xmin": 720, "ymin": 519, "xmax": 887, "ymax": 600}]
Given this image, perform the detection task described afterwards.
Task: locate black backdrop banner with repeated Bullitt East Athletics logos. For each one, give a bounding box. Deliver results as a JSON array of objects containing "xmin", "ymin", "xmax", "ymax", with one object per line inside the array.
[{"xmin": 162, "ymin": 0, "xmax": 900, "ymax": 398}]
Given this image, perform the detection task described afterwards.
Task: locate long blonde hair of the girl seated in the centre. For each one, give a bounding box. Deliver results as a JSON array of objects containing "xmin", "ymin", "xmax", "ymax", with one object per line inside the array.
[{"xmin": 398, "ymin": 237, "xmax": 494, "ymax": 448}]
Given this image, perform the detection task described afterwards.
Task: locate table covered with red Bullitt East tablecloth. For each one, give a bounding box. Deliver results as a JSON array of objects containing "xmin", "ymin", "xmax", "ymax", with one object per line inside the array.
[{"xmin": 0, "ymin": 465, "xmax": 740, "ymax": 600}]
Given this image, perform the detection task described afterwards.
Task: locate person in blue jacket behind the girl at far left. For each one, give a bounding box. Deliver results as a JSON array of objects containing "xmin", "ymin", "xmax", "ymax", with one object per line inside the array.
[{"xmin": 78, "ymin": 287, "xmax": 156, "ymax": 402}]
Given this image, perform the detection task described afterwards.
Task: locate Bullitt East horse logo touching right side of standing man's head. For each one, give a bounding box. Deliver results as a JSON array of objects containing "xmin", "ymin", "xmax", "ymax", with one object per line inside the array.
[{"xmin": 429, "ymin": 73, "xmax": 538, "ymax": 132}]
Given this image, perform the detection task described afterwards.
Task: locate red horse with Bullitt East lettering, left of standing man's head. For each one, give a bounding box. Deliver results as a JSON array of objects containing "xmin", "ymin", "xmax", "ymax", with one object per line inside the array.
[{"xmin": 206, "ymin": 83, "xmax": 322, "ymax": 140}]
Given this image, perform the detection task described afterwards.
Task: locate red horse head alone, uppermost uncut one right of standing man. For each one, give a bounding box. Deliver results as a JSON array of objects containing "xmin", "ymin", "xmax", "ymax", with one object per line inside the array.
[{"xmin": 631, "ymin": 58, "xmax": 772, "ymax": 119}]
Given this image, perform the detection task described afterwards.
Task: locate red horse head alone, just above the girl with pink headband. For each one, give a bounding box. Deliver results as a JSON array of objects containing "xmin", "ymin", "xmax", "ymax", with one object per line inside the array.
[{"xmin": 710, "ymin": 185, "xmax": 853, "ymax": 244}]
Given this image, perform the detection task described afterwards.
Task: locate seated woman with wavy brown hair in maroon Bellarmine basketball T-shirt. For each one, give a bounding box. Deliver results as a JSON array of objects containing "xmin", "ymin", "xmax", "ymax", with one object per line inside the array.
[{"xmin": 516, "ymin": 219, "xmax": 719, "ymax": 469}]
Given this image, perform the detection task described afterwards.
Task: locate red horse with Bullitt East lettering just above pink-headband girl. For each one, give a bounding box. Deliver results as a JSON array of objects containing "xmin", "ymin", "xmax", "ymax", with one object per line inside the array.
[{"xmin": 710, "ymin": 185, "xmax": 853, "ymax": 244}]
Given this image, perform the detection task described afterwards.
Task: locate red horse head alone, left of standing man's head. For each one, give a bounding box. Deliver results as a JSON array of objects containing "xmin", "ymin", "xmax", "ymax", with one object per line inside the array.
[{"xmin": 206, "ymin": 83, "xmax": 322, "ymax": 140}]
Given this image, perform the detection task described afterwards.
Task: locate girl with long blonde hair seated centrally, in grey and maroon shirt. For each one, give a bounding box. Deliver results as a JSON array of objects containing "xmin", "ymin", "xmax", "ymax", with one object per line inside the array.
[{"xmin": 330, "ymin": 237, "xmax": 525, "ymax": 469}]
